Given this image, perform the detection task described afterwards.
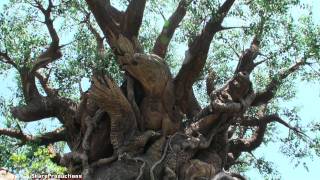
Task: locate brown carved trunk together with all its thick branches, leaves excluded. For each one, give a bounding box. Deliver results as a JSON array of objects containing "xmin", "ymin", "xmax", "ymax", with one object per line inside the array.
[{"xmin": 0, "ymin": 0, "xmax": 312, "ymax": 180}]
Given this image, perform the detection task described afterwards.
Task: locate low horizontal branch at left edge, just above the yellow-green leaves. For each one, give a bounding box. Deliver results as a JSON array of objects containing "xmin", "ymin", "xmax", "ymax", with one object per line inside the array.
[{"xmin": 0, "ymin": 128, "xmax": 66, "ymax": 145}]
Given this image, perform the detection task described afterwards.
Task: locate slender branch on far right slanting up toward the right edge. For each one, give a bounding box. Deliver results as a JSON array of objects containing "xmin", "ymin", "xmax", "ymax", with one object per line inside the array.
[{"xmin": 252, "ymin": 60, "xmax": 306, "ymax": 106}]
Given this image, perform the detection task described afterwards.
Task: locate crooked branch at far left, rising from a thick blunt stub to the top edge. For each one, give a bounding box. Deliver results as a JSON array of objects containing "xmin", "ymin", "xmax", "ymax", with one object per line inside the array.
[{"xmin": 7, "ymin": 0, "xmax": 79, "ymax": 122}]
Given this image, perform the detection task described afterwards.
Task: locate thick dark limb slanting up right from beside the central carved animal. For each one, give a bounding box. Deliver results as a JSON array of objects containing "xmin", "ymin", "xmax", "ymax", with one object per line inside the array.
[{"xmin": 175, "ymin": 0, "xmax": 235, "ymax": 116}]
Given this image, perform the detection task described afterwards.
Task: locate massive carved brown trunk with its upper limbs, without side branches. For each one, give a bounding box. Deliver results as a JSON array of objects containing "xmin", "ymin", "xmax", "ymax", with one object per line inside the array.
[{"xmin": 75, "ymin": 0, "xmax": 238, "ymax": 180}]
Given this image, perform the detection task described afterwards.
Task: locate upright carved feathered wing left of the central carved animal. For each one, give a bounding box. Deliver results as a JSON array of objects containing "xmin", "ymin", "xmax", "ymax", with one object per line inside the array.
[{"xmin": 89, "ymin": 76, "xmax": 137, "ymax": 151}]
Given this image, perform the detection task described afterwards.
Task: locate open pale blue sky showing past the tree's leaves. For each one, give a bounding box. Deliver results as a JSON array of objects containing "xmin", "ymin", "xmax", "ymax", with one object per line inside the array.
[{"xmin": 0, "ymin": 0, "xmax": 320, "ymax": 180}]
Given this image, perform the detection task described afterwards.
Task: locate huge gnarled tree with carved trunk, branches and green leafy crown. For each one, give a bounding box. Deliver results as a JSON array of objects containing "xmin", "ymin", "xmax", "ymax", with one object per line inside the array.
[{"xmin": 0, "ymin": 0, "xmax": 320, "ymax": 180}]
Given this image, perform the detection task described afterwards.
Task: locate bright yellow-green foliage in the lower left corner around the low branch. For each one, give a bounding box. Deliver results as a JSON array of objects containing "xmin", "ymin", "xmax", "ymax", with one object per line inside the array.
[{"xmin": 0, "ymin": 95, "xmax": 66, "ymax": 178}]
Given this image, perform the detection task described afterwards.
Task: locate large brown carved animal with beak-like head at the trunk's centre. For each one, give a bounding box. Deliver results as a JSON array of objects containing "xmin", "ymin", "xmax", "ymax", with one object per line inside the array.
[{"xmin": 123, "ymin": 53, "xmax": 180, "ymax": 134}]
